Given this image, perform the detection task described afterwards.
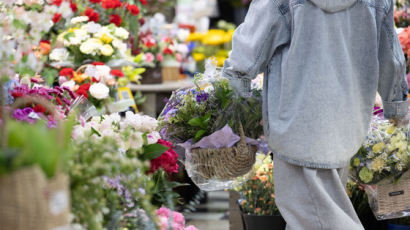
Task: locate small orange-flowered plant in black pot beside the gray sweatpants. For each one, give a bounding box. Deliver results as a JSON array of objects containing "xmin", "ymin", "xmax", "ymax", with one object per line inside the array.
[{"xmin": 235, "ymin": 153, "xmax": 286, "ymax": 230}]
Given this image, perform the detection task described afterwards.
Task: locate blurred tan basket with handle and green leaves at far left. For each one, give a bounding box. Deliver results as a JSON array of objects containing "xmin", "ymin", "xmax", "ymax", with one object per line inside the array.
[{"xmin": 0, "ymin": 95, "xmax": 74, "ymax": 230}]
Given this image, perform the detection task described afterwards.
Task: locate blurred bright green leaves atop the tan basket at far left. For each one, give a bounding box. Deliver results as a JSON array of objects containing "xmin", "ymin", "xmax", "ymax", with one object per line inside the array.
[{"xmin": 0, "ymin": 117, "xmax": 74, "ymax": 178}]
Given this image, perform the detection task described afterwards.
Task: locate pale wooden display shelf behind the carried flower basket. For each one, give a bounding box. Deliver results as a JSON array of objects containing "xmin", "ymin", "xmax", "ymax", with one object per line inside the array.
[{"xmin": 129, "ymin": 79, "xmax": 194, "ymax": 117}]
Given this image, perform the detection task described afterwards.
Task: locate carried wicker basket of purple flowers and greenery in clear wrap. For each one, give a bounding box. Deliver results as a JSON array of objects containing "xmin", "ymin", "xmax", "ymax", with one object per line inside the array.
[{"xmin": 159, "ymin": 62, "xmax": 263, "ymax": 190}]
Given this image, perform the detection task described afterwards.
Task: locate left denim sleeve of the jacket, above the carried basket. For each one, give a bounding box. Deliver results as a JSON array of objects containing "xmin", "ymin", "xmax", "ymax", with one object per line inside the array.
[{"xmin": 222, "ymin": 0, "xmax": 290, "ymax": 94}]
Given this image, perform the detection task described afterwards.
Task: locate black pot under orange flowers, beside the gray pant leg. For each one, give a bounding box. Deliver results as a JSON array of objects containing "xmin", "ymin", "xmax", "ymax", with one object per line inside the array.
[{"xmin": 242, "ymin": 213, "xmax": 286, "ymax": 230}]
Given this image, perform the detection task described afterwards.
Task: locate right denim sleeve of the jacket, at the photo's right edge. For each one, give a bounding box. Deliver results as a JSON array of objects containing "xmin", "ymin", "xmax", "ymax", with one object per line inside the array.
[{"xmin": 378, "ymin": 1, "xmax": 408, "ymax": 119}]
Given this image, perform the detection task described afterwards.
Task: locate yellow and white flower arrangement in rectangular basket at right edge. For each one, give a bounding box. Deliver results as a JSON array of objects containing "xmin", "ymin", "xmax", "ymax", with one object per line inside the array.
[{"xmin": 351, "ymin": 110, "xmax": 410, "ymax": 219}]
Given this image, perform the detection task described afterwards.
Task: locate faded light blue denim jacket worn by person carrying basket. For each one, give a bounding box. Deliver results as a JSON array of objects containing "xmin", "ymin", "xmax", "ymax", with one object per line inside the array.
[{"xmin": 222, "ymin": 0, "xmax": 408, "ymax": 168}]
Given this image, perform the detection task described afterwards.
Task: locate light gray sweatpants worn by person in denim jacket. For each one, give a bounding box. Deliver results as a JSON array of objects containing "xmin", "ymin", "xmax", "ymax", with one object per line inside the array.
[{"xmin": 274, "ymin": 157, "xmax": 364, "ymax": 230}]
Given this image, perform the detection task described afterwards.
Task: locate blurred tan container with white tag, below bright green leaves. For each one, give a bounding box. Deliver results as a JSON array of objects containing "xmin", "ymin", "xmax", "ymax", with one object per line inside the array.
[{"xmin": 0, "ymin": 166, "xmax": 70, "ymax": 230}]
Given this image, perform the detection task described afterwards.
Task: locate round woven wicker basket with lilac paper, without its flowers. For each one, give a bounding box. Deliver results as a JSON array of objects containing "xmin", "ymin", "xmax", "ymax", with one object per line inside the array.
[{"xmin": 190, "ymin": 125, "xmax": 257, "ymax": 180}]
